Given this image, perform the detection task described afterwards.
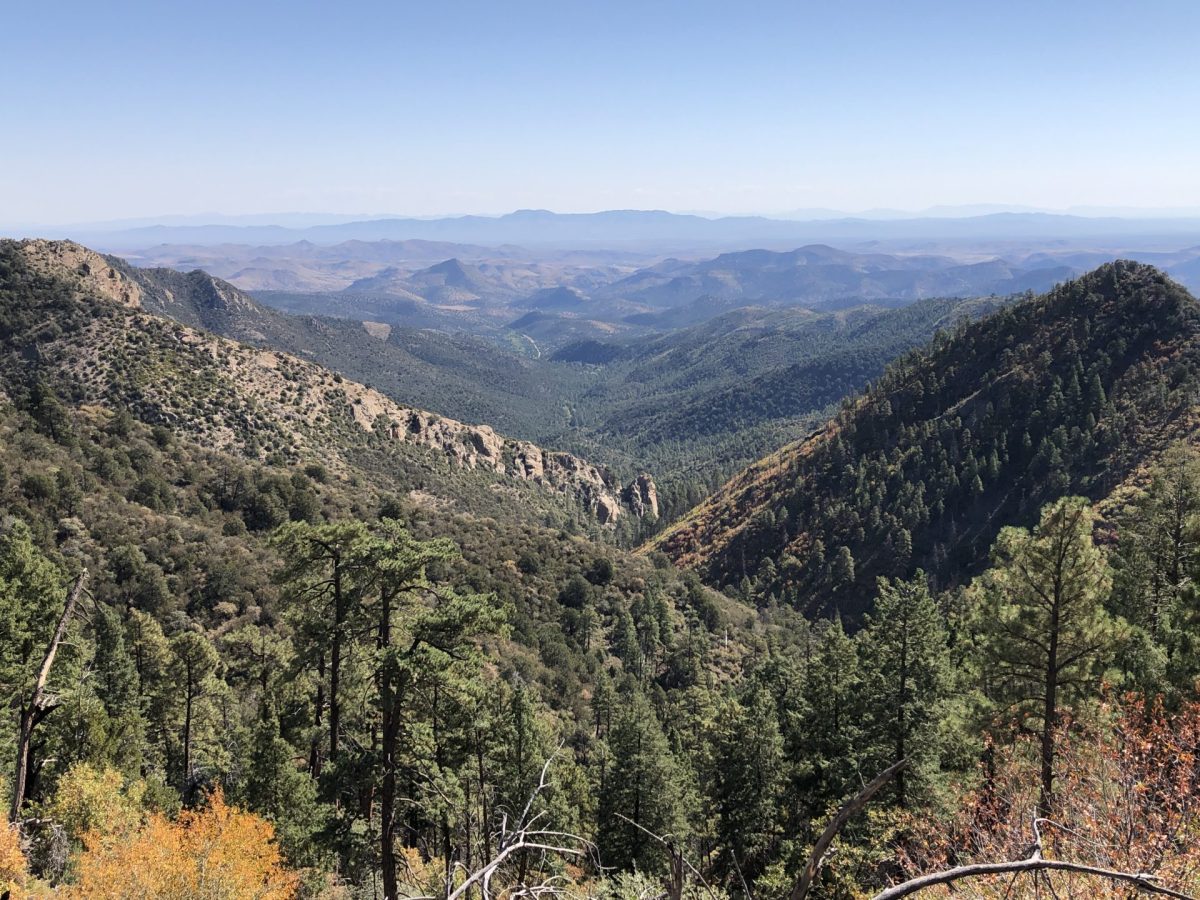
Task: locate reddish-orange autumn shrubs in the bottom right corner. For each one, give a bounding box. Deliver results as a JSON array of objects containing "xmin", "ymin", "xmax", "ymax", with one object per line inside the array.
[{"xmin": 900, "ymin": 697, "xmax": 1200, "ymax": 900}]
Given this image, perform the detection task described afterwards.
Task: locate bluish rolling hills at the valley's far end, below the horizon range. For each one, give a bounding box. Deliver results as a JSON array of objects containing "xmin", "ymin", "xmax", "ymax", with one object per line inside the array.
[{"xmin": 225, "ymin": 244, "xmax": 1080, "ymax": 354}]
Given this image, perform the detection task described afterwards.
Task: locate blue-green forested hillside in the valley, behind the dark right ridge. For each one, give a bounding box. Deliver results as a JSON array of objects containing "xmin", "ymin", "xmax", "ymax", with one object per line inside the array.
[{"xmin": 546, "ymin": 299, "xmax": 1001, "ymax": 518}]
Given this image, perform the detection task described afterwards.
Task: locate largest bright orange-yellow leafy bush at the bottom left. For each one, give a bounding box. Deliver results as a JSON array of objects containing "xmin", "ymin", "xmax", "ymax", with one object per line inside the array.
[{"xmin": 65, "ymin": 791, "xmax": 299, "ymax": 900}]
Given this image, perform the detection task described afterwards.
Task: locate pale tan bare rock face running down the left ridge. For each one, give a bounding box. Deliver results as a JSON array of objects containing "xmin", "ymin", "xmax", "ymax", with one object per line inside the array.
[{"xmin": 9, "ymin": 241, "xmax": 633, "ymax": 524}]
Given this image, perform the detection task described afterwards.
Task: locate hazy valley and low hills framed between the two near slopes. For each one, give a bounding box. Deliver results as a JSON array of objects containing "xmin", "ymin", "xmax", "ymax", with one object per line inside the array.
[{"xmin": 44, "ymin": 229, "xmax": 1200, "ymax": 522}]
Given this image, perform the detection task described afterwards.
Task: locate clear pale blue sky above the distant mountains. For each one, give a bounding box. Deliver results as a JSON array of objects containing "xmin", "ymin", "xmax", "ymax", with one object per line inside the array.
[{"xmin": 0, "ymin": 0, "xmax": 1200, "ymax": 223}]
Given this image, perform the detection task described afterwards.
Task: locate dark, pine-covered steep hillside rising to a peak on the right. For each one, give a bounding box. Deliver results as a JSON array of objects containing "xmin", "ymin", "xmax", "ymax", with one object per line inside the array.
[{"xmin": 655, "ymin": 256, "xmax": 1200, "ymax": 613}]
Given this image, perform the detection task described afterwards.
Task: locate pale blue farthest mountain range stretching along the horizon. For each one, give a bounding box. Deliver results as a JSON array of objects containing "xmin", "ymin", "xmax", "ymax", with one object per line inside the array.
[{"xmin": 23, "ymin": 210, "xmax": 1200, "ymax": 251}]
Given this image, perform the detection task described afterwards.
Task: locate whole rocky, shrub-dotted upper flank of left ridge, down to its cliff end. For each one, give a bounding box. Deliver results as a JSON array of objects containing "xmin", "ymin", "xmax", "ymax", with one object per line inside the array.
[{"xmin": 0, "ymin": 241, "xmax": 657, "ymax": 523}]
